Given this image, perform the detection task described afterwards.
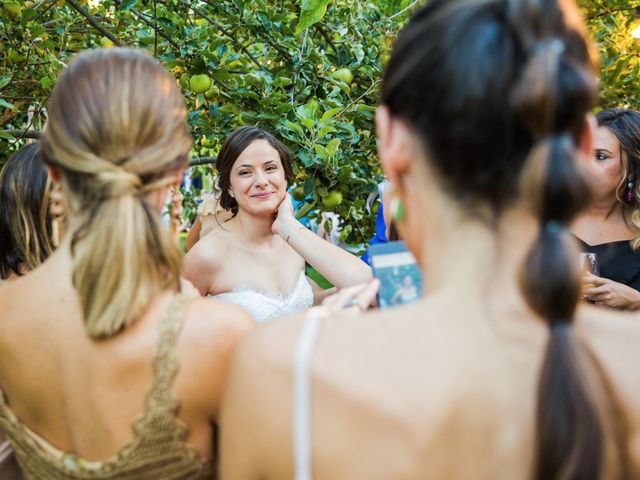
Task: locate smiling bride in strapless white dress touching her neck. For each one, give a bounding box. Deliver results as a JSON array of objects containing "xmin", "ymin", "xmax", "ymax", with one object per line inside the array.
[{"xmin": 185, "ymin": 127, "xmax": 371, "ymax": 323}]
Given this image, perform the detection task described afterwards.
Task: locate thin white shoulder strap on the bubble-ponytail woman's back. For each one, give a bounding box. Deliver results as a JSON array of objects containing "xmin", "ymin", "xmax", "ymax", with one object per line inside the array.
[{"xmin": 293, "ymin": 307, "xmax": 326, "ymax": 480}]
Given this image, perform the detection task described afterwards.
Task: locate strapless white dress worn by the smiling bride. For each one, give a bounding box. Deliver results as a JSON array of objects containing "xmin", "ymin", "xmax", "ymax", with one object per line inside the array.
[{"xmin": 209, "ymin": 271, "xmax": 313, "ymax": 323}]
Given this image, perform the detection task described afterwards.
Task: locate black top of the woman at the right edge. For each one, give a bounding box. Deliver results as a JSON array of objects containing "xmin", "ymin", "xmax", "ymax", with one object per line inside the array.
[{"xmin": 574, "ymin": 235, "xmax": 640, "ymax": 291}]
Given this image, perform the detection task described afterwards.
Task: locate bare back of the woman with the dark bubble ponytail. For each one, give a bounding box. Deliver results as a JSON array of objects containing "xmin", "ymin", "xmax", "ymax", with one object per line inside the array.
[{"xmin": 222, "ymin": 286, "xmax": 640, "ymax": 480}]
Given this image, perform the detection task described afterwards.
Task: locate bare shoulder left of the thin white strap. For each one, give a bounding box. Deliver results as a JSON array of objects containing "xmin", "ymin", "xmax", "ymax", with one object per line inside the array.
[{"xmin": 220, "ymin": 314, "xmax": 304, "ymax": 478}]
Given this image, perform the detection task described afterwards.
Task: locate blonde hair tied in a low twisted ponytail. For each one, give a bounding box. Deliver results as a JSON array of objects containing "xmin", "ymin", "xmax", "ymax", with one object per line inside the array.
[{"xmin": 42, "ymin": 48, "xmax": 191, "ymax": 339}]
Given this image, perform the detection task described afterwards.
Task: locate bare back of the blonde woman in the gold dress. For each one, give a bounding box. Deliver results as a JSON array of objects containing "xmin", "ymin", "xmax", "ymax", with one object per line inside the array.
[{"xmin": 0, "ymin": 246, "xmax": 250, "ymax": 478}]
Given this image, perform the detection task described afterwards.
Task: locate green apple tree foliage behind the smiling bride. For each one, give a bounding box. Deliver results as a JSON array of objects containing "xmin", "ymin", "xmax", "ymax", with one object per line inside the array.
[{"xmin": 0, "ymin": 0, "xmax": 418, "ymax": 244}]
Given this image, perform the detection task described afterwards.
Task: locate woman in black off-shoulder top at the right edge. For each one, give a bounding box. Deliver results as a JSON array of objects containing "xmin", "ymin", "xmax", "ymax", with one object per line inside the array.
[{"xmin": 571, "ymin": 108, "xmax": 640, "ymax": 310}]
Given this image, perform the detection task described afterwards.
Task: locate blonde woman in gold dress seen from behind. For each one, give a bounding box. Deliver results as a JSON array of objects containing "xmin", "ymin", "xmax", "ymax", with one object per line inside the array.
[{"xmin": 0, "ymin": 48, "xmax": 252, "ymax": 480}]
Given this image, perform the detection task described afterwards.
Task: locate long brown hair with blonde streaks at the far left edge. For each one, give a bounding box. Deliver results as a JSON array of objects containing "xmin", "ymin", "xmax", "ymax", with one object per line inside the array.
[{"xmin": 0, "ymin": 143, "xmax": 53, "ymax": 280}]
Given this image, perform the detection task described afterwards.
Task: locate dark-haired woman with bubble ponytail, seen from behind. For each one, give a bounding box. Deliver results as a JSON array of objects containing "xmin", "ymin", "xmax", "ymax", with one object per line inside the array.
[{"xmin": 221, "ymin": 0, "xmax": 640, "ymax": 480}]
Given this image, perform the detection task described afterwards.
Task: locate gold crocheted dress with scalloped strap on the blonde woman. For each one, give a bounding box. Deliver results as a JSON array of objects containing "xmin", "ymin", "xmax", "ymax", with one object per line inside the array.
[{"xmin": 0, "ymin": 295, "xmax": 214, "ymax": 480}]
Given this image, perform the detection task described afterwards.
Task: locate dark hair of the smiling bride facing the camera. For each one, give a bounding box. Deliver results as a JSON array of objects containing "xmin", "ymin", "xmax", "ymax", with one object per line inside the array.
[{"xmin": 216, "ymin": 126, "xmax": 293, "ymax": 215}]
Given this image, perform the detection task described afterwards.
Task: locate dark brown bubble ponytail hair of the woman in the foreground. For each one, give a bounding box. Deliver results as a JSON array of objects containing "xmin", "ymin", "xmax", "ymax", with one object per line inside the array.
[{"xmin": 382, "ymin": 0, "xmax": 629, "ymax": 480}]
